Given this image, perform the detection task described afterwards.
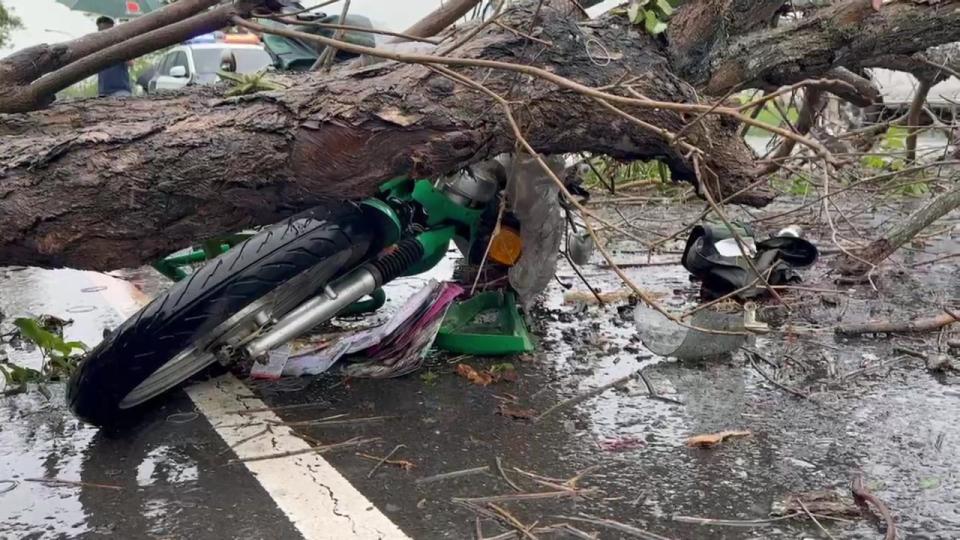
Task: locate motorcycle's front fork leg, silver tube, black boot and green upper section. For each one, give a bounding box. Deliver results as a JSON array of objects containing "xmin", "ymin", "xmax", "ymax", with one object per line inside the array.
[{"xmin": 244, "ymin": 226, "xmax": 455, "ymax": 359}]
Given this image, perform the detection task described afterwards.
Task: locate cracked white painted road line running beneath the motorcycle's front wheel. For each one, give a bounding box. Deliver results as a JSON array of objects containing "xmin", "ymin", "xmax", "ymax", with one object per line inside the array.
[{"xmin": 88, "ymin": 273, "xmax": 409, "ymax": 540}]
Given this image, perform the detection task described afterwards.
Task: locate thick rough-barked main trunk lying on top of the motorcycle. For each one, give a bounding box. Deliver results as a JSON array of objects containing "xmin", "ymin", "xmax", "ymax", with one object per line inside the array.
[{"xmin": 0, "ymin": 2, "xmax": 770, "ymax": 269}]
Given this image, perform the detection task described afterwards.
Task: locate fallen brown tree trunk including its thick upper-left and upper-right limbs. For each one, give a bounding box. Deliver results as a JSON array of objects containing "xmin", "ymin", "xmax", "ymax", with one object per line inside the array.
[{"xmin": 0, "ymin": 0, "xmax": 960, "ymax": 269}]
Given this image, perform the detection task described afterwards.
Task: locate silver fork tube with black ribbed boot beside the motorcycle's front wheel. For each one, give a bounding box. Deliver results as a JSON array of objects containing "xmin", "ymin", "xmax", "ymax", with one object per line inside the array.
[{"xmin": 244, "ymin": 238, "xmax": 424, "ymax": 358}]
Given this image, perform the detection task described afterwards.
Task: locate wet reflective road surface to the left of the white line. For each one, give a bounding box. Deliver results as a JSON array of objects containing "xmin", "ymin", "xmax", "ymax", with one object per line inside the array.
[{"xmin": 0, "ymin": 268, "xmax": 296, "ymax": 539}]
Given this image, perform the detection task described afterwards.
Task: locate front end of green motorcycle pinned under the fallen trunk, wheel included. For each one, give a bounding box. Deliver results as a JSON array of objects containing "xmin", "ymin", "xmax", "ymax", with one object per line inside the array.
[{"xmin": 67, "ymin": 173, "xmax": 520, "ymax": 426}]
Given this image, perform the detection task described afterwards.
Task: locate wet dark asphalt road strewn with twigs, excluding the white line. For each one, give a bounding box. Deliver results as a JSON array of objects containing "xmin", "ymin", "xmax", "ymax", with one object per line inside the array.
[{"xmin": 0, "ymin": 208, "xmax": 960, "ymax": 539}]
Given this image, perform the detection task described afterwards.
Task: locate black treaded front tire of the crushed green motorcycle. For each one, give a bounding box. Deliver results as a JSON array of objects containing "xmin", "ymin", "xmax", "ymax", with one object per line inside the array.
[{"xmin": 67, "ymin": 204, "xmax": 379, "ymax": 426}]
